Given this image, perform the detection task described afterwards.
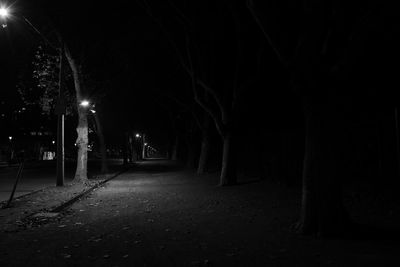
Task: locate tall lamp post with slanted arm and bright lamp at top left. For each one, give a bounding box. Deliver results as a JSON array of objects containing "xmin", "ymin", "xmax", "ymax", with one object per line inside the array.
[{"xmin": 0, "ymin": 4, "xmax": 66, "ymax": 186}]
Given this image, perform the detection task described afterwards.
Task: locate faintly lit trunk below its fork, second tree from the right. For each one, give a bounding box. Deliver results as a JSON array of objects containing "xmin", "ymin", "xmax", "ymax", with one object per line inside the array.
[{"xmin": 220, "ymin": 132, "xmax": 237, "ymax": 186}]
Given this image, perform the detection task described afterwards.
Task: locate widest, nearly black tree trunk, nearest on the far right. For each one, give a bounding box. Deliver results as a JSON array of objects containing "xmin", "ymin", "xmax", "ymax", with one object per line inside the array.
[{"xmin": 298, "ymin": 97, "xmax": 349, "ymax": 236}]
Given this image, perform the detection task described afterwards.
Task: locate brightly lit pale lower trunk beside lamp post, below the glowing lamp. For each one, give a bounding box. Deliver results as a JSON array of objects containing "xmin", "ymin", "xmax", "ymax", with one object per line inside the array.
[{"xmin": 74, "ymin": 106, "xmax": 88, "ymax": 182}]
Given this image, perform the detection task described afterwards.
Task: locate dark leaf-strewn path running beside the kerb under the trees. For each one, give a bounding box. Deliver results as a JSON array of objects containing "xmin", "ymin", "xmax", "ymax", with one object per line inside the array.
[{"xmin": 0, "ymin": 161, "xmax": 400, "ymax": 266}]
